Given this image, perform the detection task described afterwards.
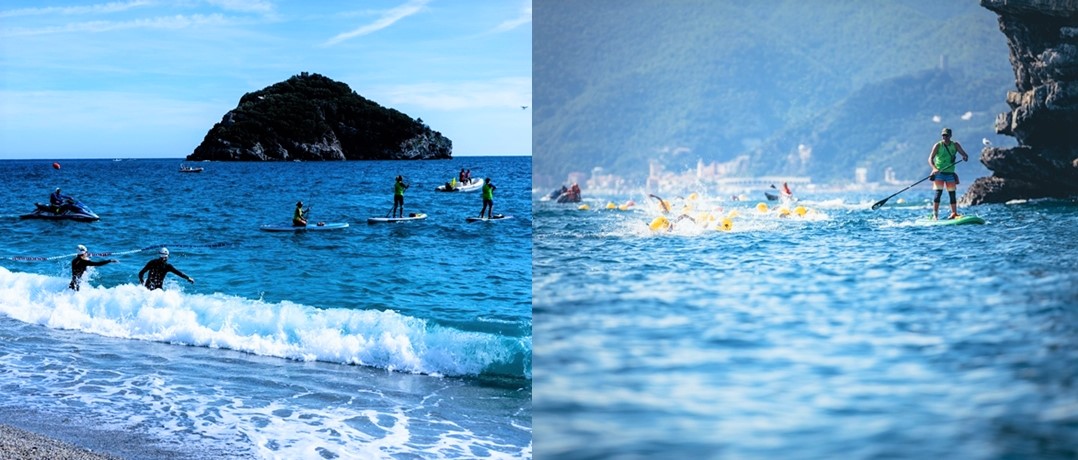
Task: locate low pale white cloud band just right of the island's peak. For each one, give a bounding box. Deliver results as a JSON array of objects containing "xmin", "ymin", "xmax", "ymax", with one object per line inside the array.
[{"xmin": 375, "ymin": 78, "xmax": 531, "ymax": 111}]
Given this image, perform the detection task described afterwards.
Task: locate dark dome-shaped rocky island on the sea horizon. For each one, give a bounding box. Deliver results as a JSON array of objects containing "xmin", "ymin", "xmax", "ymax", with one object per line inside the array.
[{"xmin": 186, "ymin": 72, "xmax": 453, "ymax": 162}]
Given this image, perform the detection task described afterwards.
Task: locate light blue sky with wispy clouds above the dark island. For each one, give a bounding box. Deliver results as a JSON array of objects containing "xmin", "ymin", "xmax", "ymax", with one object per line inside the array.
[{"xmin": 0, "ymin": 0, "xmax": 531, "ymax": 159}]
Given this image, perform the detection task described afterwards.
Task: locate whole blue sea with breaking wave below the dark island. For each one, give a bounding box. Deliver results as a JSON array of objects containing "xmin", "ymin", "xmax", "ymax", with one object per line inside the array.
[{"xmin": 0, "ymin": 156, "xmax": 531, "ymax": 459}]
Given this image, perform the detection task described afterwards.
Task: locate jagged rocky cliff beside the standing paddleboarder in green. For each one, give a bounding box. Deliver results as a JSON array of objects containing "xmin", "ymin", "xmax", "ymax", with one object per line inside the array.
[{"xmin": 963, "ymin": 0, "xmax": 1078, "ymax": 205}]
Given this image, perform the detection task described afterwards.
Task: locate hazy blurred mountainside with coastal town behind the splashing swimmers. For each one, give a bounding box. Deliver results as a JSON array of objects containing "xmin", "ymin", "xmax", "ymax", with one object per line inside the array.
[{"xmin": 533, "ymin": 0, "xmax": 1015, "ymax": 186}]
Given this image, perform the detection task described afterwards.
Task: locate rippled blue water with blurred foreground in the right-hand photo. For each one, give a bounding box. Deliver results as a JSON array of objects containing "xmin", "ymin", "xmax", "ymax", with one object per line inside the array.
[{"xmin": 533, "ymin": 190, "xmax": 1078, "ymax": 459}]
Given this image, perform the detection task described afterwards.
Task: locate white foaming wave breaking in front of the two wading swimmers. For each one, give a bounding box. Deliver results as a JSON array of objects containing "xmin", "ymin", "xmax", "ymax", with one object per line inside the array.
[{"xmin": 0, "ymin": 267, "xmax": 520, "ymax": 376}]
